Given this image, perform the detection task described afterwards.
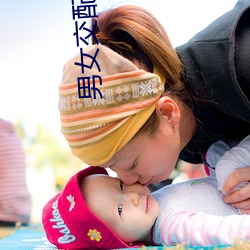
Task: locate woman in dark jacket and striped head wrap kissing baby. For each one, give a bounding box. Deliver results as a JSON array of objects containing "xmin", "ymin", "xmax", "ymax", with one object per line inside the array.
[{"xmin": 59, "ymin": 0, "xmax": 250, "ymax": 211}]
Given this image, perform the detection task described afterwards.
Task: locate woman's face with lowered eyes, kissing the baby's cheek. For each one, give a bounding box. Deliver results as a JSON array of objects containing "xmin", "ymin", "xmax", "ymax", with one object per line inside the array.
[{"xmin": 101, "ymin": 116, "xmax": 181, "ymax": 185}]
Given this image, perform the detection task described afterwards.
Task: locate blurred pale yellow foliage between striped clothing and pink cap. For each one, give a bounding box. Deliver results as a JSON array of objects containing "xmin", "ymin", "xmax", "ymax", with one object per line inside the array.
[{"xmin": 14, "ymin": 120, "xmax": 85, "ymax": 191}]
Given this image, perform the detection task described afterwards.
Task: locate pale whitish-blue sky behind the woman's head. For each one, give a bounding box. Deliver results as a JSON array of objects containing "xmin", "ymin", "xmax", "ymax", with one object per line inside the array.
[{"xmin": 0, "ymin": 0, "xmax": 237, "ymax": 137}]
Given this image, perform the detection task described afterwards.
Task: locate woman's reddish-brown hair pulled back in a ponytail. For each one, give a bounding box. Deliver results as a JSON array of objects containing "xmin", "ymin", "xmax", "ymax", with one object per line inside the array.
[{"xmin": 92, "ymin": 5, "xmax": 195, "ymax": 134}]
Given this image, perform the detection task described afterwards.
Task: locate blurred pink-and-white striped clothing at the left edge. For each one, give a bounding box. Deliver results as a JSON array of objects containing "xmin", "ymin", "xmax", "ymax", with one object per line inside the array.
[{"xmin": 0, "ymin": 119, "xmax": 31, "ymax": 223}]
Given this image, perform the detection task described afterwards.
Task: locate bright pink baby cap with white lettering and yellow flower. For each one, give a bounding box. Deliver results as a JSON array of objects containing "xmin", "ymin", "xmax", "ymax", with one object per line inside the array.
[{"xmin": 42, "ymin": 167, "xmax": 142, "ymax": 249}]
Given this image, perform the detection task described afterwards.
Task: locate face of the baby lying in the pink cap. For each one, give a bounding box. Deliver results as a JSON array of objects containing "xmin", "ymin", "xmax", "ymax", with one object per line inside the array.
[{"xmin": 85, "ymin": 175, "xmax": 160, "ymax": 243}]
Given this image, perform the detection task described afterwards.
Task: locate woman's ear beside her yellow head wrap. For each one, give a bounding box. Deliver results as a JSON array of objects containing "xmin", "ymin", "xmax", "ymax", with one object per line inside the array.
[{"xmin": 156, "ymin": 96, "xmax": 180, "ymax": 126}]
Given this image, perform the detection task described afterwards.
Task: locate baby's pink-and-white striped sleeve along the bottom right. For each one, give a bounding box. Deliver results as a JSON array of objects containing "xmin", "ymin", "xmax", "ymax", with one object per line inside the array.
[{"xmin": 160, "ymin": 211, "xmax": 250, "ymax": 246}]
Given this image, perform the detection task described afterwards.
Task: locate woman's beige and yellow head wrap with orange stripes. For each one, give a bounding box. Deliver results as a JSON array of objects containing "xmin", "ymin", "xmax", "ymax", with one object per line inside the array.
[{"xmin": 59, "ymin": 43, "xmax": 165, "ymax": 166}]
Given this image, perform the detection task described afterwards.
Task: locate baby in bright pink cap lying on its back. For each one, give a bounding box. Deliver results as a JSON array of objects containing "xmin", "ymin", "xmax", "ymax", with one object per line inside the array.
[{"xmin": 42, "ymin": 136, "xmax": 250, "ymax": 249}]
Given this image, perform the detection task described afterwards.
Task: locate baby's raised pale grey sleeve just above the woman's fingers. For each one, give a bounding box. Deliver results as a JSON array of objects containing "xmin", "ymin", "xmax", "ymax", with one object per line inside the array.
[{"xmin": 215, "ymin": 135, "xmax": 250, "ymax": 190}]
